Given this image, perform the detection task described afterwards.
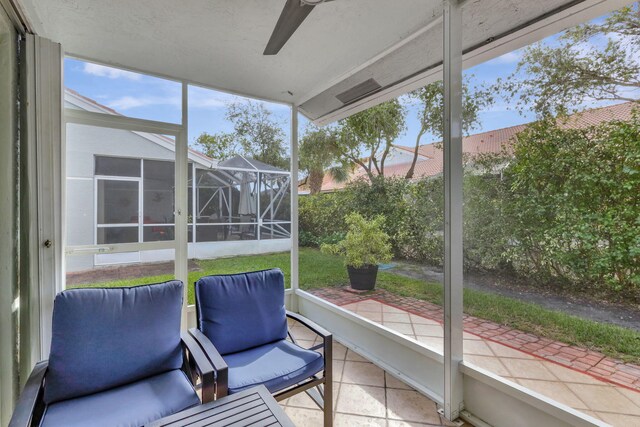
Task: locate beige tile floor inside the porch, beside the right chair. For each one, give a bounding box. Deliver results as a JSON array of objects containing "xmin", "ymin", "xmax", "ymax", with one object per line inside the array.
[{"xmin": 280, "ymin": 322, "xmax": 469, "ymax": 427}]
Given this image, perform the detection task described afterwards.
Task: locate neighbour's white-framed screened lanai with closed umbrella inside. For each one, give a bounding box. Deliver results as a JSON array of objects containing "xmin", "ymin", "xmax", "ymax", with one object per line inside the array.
[{"xmin": 189, "ymin": 156, "xmax": 291, "ymax": 243}]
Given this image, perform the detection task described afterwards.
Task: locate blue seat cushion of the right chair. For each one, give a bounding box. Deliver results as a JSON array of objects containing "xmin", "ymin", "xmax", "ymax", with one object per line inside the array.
[{"xmin": 224, "ymin": 340, "xmax": 324, "ymax": 393}]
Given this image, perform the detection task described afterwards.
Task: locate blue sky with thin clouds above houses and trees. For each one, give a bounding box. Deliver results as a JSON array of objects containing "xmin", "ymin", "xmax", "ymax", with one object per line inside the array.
[{"xmin": 64, "ymin": 10, "xmax": 624, "ymax": 152}]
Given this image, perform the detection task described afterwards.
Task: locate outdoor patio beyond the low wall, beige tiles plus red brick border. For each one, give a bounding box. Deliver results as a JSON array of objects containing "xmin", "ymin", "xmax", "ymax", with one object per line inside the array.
[{"xmin": 314, "ymin": 288, "xmax": 640, "ymax": 426}]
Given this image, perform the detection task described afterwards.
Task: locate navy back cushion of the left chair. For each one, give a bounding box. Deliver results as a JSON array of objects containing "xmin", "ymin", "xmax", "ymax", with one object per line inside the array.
[{"xmin": 44, "ymin": 280, "xmax": 183, "ymax": 404}]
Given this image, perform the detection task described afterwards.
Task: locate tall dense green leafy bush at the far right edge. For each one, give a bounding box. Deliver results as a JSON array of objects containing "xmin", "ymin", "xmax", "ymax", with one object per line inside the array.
[{"xmin": 505, "ymin": 115, "xmax": 640, "ymax": 291}]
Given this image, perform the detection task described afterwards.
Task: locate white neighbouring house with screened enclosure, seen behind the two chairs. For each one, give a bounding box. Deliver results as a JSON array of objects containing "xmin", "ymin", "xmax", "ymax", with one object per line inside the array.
[{"xmin": 64, "ymin": 89, "xmax": 291, "ymax": 271}]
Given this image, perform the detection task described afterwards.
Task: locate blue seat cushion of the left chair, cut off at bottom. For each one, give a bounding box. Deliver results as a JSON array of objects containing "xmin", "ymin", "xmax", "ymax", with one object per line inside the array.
[{"xmin": 40, "ymin": 369, "xmax": 200, "ymax": 427}]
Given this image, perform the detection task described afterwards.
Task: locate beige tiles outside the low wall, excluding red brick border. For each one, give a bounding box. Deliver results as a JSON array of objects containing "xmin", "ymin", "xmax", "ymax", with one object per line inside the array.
[{"xmin": 342, "ymin": 300, "xmax": 640, "ymax": 426}]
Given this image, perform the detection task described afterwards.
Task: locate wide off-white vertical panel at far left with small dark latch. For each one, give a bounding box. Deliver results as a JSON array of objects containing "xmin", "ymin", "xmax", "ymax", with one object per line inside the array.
[{"xmin": 20, "ymin": 34, "xmax": 65, "ymax": 372}]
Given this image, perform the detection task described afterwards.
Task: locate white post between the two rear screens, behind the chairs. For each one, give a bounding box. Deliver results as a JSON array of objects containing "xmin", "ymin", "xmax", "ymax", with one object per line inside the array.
[{"xmin": 174, "ymin": 82, "xmax": 189, "ymax": 329}]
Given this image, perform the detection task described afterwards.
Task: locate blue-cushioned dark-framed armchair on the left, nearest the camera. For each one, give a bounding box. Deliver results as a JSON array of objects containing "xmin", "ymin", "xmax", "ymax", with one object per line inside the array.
[{"xmin": 9, "ymin": 281, "xmax": 214, "ymax": 427}]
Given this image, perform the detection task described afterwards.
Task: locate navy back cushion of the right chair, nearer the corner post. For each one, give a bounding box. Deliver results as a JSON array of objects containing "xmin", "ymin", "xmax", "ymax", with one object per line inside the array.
[{"xmin": 195, "ymin": 269, "xmax": 287, "ymax": 355}]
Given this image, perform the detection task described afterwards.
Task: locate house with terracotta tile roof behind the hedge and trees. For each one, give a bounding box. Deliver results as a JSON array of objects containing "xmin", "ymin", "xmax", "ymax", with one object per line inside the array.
[{"xmin": 300, "ymin": 102, "xmax": 638, "ymax": 193}]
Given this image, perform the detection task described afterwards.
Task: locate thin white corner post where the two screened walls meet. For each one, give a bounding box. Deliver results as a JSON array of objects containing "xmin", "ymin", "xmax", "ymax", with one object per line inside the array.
[{"xmin": 290, "ymin": 104, "xmax": 299, "ymax": 312}]
